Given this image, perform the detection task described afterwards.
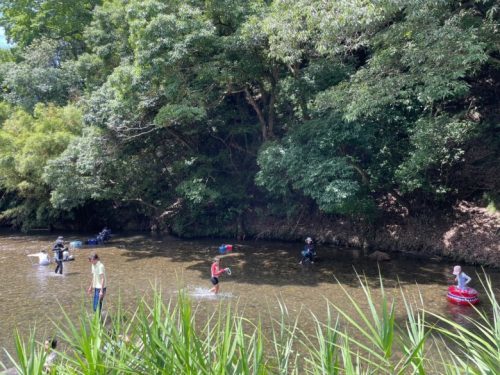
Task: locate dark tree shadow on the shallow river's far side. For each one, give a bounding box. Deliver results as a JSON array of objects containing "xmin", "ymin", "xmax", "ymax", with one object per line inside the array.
[{"xmin": 113, "ymin": 237, "xmax": 464, "ymax": 288}]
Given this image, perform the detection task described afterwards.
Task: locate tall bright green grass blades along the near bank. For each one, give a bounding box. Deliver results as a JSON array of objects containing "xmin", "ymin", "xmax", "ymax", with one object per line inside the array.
[{"xmin": 1, "ymin": 276, "xmax": 500, "ymax": 375}]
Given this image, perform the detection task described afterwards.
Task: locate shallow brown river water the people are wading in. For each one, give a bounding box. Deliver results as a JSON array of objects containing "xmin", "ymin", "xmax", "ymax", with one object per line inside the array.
[{"xmin": 0, "ymin": 233, "xmax": 500, "ymax": 368}]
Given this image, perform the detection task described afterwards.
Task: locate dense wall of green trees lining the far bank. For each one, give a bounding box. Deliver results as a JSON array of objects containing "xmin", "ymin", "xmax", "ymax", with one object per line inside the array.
[{"xmin": 0, "ymin": 0, "xmax": 500, "ymax": 235}]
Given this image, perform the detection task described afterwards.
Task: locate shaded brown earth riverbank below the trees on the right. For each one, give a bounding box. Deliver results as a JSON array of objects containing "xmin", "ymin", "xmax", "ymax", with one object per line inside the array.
[{"xmin": 240, "ymin": 201, "xmax": 500, "ymax": 268}]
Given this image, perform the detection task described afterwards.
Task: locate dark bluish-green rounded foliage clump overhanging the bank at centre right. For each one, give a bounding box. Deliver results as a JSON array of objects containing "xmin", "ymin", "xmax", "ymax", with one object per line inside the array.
[{"xmin": 256, "ymin": 116, "xmax": 372, "ymax": 214}]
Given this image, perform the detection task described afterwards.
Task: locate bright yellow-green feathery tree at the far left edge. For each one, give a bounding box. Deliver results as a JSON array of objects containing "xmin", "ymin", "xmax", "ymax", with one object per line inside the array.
[{"xmin": 0, "ymin": 104, "xmax": 82, "ymax": 228}]
